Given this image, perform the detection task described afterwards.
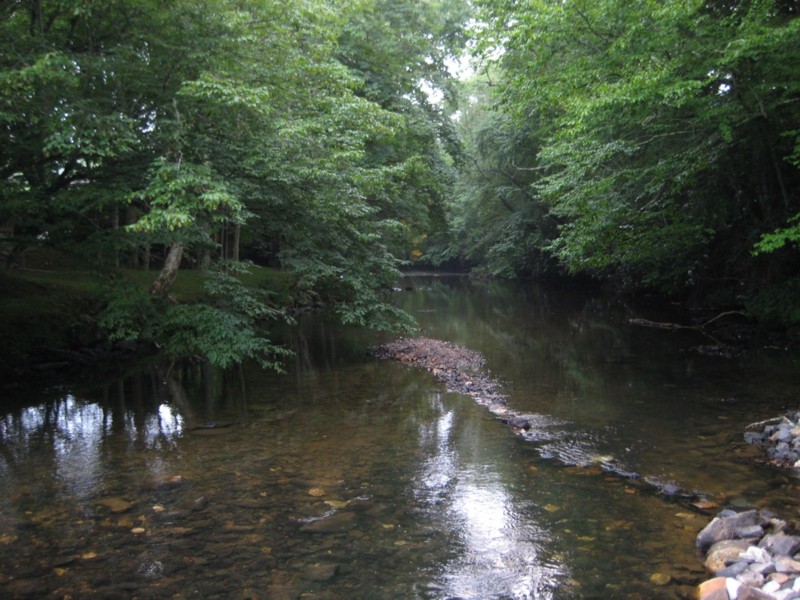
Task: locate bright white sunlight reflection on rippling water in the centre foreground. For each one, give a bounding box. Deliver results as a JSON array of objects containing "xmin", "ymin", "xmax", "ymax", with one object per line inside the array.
[{"xmin": 415, "ymin": 396, "xmax": 568, "ymax": 599}]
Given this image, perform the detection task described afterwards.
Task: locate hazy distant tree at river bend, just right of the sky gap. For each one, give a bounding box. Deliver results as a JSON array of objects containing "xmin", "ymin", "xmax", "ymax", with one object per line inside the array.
[{"xmin": 442, "ymin": 78, "xmax": 556, "ymax": 277}]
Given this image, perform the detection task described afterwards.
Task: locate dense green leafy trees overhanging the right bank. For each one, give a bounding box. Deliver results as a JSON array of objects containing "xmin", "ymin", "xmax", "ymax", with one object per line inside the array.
[{"xmin": 457, "ymin": 0, "xmax": 800, "ymax": 324}]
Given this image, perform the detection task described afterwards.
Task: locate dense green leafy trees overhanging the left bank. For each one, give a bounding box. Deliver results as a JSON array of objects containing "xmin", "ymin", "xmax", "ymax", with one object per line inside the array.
[{"xmin": 0, "ymin": 0, "xmax": 466, "ymax": 364}]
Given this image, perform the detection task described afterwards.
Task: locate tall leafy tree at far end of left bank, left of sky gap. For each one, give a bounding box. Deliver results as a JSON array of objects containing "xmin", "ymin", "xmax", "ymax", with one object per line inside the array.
[{"xmin": 337, "ymin": 0, "xmax": 469, "ymax": 258}]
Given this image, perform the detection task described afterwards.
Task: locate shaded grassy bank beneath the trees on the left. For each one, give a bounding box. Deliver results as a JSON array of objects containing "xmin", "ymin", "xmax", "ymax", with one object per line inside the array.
[{"xmin": 0, "ymin": 267, "xmax": 294, "ymax": 373}]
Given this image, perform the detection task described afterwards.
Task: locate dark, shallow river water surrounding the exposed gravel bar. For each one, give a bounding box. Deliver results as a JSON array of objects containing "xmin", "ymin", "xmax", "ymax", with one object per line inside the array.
[{"xmin": 0, "ymin": 277, "xmax": 800, "ymax": 599}]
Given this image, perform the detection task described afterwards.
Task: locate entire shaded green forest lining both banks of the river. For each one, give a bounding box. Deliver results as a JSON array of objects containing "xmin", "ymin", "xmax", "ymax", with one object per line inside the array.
[{"xmin": 0, "ymin": 0, "xmax": 800, "ymax": 365}]
